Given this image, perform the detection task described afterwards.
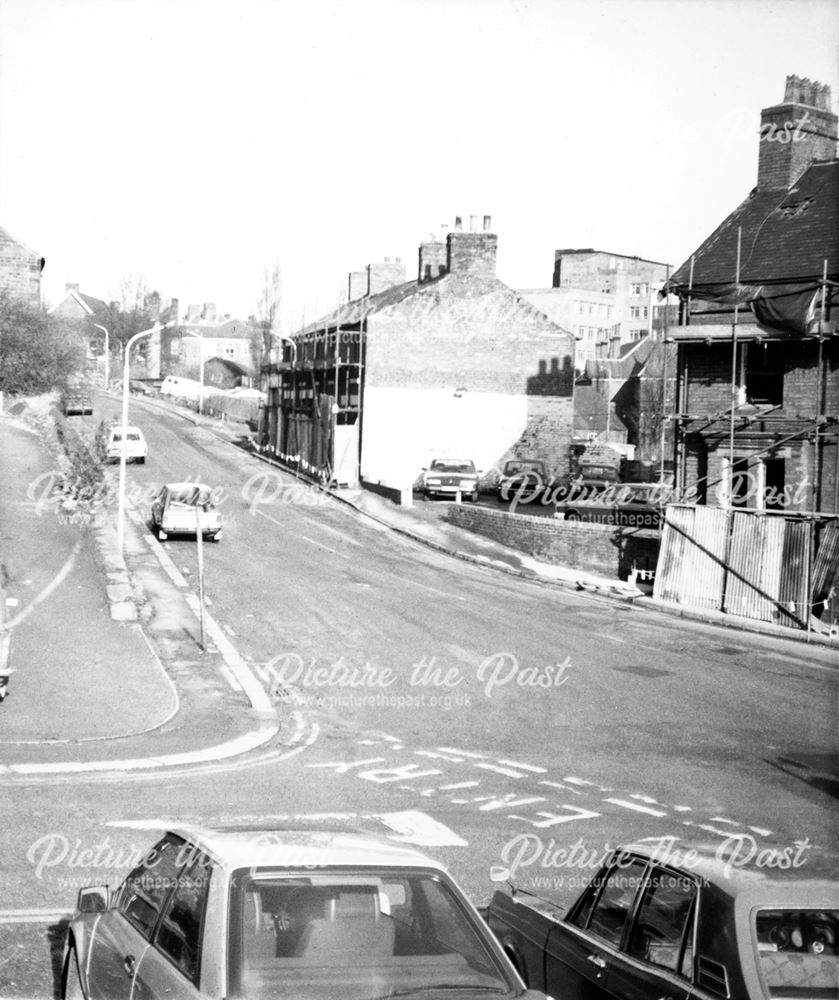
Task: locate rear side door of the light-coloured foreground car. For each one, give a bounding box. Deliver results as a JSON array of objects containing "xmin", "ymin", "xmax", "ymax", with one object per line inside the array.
[{"xmin": 132, "ymin": 855, "xmax": 212, "ymax": 1000}]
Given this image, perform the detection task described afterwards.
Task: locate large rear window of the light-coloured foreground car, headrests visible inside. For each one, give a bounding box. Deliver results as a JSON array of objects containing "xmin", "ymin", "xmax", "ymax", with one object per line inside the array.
[{"xmin": 229, "ymin": 869, "xmax": 515, "ymax": 1000}]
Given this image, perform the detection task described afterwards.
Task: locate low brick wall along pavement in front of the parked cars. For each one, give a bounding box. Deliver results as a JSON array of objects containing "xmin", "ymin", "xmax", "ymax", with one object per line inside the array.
[{"xmin": 446, "ymin": 504, "xmax": 659, "ymax": 580}]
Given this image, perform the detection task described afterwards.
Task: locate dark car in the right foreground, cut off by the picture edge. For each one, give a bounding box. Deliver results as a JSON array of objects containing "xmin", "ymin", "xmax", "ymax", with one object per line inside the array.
[{"xmin": 487, "ymin": 844, "xmax": 839, "ymax": 1000}]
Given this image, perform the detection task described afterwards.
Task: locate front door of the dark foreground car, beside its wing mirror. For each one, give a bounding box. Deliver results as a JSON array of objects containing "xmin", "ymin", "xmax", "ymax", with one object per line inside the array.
[{"xmin": 545, "ymin": 858, "xmax": 647, "ymax": 1000}]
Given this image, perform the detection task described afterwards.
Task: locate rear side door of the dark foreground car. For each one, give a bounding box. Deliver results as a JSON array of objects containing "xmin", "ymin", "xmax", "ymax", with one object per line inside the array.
[{"xmin": 606, "ymin": 867, "xmax": 698, "ymax": 1000}]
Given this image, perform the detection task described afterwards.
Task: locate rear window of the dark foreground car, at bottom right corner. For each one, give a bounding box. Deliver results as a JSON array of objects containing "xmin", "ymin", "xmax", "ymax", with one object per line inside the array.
[{"xmin": 755, "ymin": 909, "xmax": 839, "ymax": 1000}]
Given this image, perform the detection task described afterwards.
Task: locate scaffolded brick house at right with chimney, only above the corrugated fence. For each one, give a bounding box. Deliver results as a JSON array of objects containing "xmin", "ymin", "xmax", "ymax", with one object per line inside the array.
[{"xmin": 670, "ymin": 76, "xmax": 839, "ymax": 514}]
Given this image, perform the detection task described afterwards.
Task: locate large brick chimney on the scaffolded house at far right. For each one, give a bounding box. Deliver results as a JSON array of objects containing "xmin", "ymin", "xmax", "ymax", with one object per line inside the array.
[{"xmin": 757, "ymin": 76, "xmax": 839, "ymax": 191}]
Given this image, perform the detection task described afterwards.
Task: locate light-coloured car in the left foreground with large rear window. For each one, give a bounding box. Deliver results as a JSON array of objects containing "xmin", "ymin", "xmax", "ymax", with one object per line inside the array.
[{"xmin": 62, "ymin": 828, "xmax": 537, "ymax": 1000}]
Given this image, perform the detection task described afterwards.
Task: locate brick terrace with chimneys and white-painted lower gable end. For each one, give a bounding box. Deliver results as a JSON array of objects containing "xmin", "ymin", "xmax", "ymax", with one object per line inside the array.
[{"xmin": 263, "ymin": 216, "xmax": 574, "ymax": 493}]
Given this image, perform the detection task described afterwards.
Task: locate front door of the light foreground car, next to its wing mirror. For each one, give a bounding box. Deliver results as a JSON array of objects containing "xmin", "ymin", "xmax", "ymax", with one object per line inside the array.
[{"xmin": 88, "ymin": 837, "xmax": 189, "ymax": 1000}]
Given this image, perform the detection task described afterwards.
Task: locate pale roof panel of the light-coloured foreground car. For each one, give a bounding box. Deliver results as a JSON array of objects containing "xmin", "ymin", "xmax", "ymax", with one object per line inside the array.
[{"xmin": 166, "ymin": 822, "xmax": 446, "ymax": 872}]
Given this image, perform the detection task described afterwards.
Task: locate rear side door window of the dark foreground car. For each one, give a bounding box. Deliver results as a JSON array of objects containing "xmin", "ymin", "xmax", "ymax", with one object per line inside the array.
[{"xmin": 627, "ymin": 869, "xmax": 696, "ymax": 972}]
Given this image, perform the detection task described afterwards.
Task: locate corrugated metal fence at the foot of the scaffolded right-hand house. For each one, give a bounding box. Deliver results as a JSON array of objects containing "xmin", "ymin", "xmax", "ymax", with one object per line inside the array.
[{"xmin": 653, "ymin": 504, "xmax": 839, "ymax": 632}]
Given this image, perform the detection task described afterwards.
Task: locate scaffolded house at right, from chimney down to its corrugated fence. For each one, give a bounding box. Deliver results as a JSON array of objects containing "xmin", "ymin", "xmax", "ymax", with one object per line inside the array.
[{"xmin": 656, "ymin": 76, "xmax": 839, "ymax": 630}]
